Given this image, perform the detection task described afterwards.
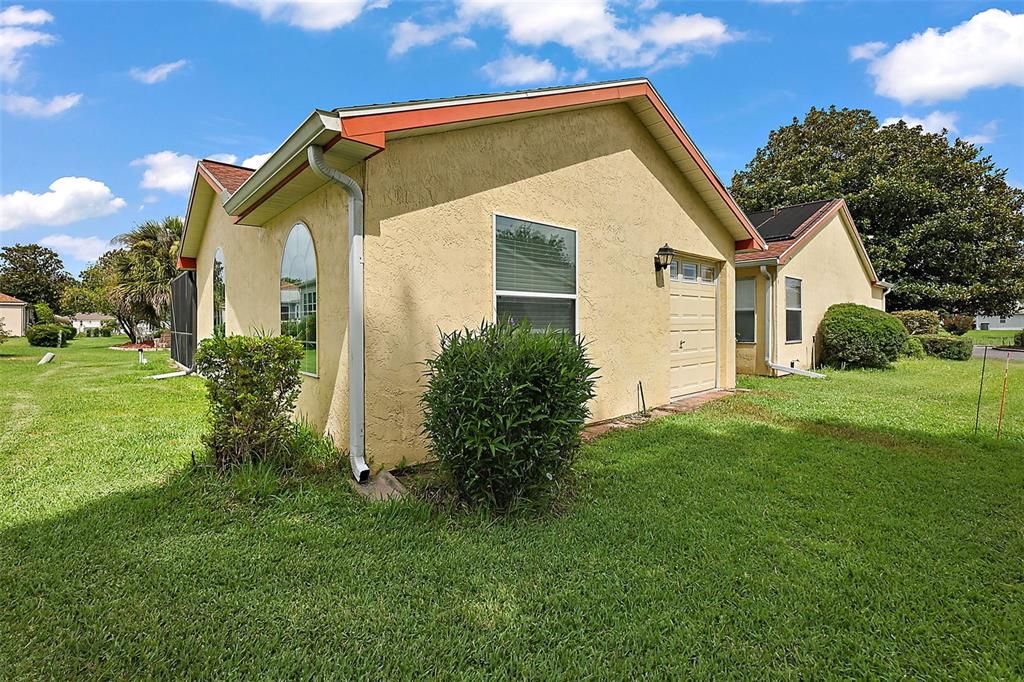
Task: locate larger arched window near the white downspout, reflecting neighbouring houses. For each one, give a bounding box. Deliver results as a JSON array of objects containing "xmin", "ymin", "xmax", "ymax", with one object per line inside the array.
[{"xmin": 281, "ymin": 222, "xmax": 316, "ymax": 374}]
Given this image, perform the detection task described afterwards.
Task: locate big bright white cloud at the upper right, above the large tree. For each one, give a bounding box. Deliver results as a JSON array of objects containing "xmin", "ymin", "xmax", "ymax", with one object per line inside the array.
[{"xmin": 867, "ymin": 9, "xmax": 1024, "ymax": 104}]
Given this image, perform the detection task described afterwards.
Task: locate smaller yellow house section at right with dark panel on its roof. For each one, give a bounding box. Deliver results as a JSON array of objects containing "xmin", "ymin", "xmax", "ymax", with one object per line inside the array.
[{"xmin": 735, "ymin": 199, "xmax": 890, "ymax": 375}]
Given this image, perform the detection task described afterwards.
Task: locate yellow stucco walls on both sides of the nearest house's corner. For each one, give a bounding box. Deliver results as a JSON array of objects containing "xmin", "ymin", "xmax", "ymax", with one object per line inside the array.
[{"xmin": 190, "ymin": 104, "xmax": 735, "ymax": 468}]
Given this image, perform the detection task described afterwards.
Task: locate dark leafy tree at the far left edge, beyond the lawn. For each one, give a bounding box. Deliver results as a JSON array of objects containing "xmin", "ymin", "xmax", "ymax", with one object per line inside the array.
[{"xmin": 0, "ymin": 244, "xmax": 74, "ymax": 311}]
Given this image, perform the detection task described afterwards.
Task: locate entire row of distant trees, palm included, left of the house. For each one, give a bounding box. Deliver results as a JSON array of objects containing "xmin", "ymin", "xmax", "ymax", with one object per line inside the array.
[{"xmin": 0, "ymin": 216, "xmax": 184, "ymax": 343}]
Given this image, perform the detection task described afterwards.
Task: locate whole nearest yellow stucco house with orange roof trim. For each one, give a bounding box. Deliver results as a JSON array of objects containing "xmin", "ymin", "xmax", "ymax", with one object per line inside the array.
[{"xmin": 175, "ymin": 79, "xmax": 764, "ymax": 479}]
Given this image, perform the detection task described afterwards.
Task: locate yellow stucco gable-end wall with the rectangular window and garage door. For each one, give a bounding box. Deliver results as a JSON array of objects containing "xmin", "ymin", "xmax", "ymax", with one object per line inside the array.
[{"xmin": 366, "ymin": 105, "xmax": 735, "ymax": 465}]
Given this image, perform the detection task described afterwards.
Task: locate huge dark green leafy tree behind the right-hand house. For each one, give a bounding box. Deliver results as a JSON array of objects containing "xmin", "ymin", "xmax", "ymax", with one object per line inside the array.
[{"xmin": 731, "ymin": 106, "xmax": 1024, "ymax": 314}]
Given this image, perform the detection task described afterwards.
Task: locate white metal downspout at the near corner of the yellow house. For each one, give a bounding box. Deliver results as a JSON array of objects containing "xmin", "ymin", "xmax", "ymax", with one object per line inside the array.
[{"xmin": 306, "ymin": 144, "xmax": 370, "ymax": 483}]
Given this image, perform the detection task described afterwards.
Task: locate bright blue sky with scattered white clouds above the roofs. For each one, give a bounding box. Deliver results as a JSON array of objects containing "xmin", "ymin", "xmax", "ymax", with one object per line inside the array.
[{"xmin": 0, "ymin": 0, "xmax": 1024, "ymax": 273}]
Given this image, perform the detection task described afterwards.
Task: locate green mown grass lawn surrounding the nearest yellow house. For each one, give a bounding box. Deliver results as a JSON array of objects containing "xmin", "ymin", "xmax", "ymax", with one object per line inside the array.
[{"xmin": 0, "ymin": 339, "xmax": 1024, "ymax": 680}]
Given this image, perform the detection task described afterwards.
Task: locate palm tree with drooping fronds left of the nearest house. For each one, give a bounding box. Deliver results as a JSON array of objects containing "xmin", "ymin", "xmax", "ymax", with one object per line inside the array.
[{"xmin": 114, "ymin": 216, "xmax": 184, "ymax": 326}]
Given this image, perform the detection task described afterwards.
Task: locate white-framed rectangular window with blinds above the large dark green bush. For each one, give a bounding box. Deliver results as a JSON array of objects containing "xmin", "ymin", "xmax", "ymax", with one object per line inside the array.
[{"xmin": 495, "ymin": 215, "xmax": 577, "ymax": 334}]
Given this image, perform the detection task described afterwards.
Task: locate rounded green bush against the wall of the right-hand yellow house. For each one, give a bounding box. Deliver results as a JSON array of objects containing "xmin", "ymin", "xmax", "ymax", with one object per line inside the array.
[{"xmin": 818, "ymin": 303, "xmax": 907, "ymax": 368}]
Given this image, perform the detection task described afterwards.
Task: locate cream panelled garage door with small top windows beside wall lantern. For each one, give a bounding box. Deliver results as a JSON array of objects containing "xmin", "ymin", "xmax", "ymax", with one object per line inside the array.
[{"xmin": 669, "ymin": 259, "xmax": 718, "ymax": 397}]
